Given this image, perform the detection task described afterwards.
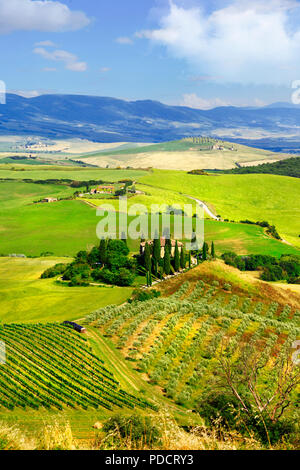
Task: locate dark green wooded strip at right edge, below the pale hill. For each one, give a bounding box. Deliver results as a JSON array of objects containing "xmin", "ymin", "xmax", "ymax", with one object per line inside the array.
[{"xmin": 224, "ymin": 157, "xmax": 300, "ymax": 178}]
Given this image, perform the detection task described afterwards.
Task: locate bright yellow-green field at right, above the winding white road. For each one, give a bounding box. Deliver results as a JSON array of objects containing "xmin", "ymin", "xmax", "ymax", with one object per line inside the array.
[{"xmin": 140, "ymin": 170, "xmax": 300, "ymax": 247}]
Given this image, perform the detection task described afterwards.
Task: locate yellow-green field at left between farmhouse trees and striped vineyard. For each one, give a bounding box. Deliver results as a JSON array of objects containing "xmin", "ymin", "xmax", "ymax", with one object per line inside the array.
[{"xmin": 0, "ymin": 258, "xmax": 132, "ymax": 322}]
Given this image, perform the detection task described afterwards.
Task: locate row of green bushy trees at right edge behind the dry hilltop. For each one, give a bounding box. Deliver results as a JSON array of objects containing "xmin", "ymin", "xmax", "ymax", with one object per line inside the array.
[{"xmin": 222, "ymin": 252, "xmax": 300, "ymax": 284}]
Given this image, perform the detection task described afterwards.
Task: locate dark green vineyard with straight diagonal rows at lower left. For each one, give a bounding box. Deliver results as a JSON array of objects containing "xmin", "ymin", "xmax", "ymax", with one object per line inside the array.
[{"xmin": 0, "ymin": 323, "xmax": 150, "ymax": 410}]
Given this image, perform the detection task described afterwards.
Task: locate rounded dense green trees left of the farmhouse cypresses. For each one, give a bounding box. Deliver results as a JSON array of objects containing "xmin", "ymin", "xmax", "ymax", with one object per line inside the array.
[{"xmin": 42, "ymin": 239, "xmax": 136, "ymax": 286}]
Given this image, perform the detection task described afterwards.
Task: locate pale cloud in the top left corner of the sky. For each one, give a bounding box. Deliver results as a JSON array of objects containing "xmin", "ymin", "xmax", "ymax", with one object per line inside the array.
[{"xmin": 0, "ymin": 0, "xmax": 90, "ymax": 34}]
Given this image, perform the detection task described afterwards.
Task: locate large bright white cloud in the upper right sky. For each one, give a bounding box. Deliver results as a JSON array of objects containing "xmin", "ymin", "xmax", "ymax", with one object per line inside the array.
[{"xmin": 137, "ymin": 0, "xmax": 300, "ymax": 84}]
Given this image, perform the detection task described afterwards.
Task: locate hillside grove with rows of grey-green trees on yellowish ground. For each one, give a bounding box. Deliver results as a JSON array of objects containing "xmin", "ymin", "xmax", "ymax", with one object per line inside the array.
[{"xmin": 86, "ymin": 280, "xmax": 300, "ymax": 406}]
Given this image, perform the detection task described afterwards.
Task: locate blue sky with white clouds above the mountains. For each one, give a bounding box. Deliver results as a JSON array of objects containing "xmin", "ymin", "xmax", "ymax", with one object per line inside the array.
[{"xmin": 0, "ymin": 0, "xmax": 300, "ymax": 109}]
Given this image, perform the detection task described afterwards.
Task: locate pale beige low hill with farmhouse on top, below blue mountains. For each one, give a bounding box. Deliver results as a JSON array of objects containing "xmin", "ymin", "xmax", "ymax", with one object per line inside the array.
[{"xmin": 80, "ymin": 137, "xmax": 289, "ymax": 171}]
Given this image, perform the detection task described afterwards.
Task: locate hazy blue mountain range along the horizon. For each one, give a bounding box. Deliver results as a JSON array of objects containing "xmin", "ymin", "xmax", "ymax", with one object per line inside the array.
[{"xmin": 0, "ymin": 94, "xmax": 300, "ymax": 153}]
